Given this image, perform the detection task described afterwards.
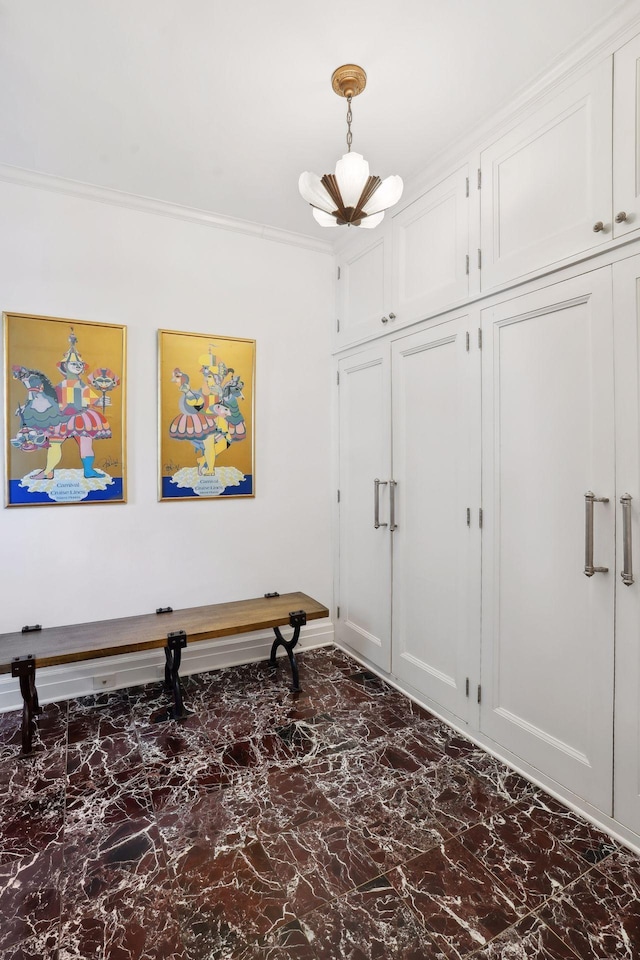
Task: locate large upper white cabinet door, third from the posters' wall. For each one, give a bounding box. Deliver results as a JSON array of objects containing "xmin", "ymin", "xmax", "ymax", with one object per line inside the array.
[{"xmin": 481, "ymin": 57, "xmax": 612, "ymax": 290}]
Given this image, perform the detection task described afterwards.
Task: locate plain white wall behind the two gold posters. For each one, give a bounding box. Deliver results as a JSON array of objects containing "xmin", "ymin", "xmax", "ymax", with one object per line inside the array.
[{"xmin": 0, "ymin": 183, "xmax": 332, "ymax": 636}]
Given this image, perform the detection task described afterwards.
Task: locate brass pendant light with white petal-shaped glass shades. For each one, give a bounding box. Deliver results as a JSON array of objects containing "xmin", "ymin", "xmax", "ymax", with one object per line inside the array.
[{"xmin": 298, "ymin": 63, "xmax": 403, "ymax": 229}]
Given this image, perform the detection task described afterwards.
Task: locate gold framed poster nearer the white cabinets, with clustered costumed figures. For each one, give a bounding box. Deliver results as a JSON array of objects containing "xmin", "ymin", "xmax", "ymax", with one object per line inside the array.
[{"xmin": 158, "ymin": 330, "xmax": 256, "ymax": 500}]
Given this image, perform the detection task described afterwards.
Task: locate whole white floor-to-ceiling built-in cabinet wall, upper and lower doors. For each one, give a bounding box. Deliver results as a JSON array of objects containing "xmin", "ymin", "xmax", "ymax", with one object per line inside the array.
[{"xmin": 335, "ymin": 20, "xmax": 640, "ymax": 845}]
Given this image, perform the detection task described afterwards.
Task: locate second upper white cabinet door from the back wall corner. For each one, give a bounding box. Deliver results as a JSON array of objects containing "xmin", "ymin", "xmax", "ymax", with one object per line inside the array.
[{"xmin": 391, "ymin": 167, "xmax": 469, "ymax": 324}]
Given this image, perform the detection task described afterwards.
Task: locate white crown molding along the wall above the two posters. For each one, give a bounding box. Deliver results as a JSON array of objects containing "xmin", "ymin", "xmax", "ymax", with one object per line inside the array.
[{"xmin": 0, "ymin": 163, "xmax": 333, "ymax": 256}]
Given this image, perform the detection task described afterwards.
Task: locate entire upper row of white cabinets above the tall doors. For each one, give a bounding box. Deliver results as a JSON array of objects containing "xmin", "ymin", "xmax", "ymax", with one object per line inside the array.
[{"xmin": 334, "ymin": 37, "xmax": 640, "ymax": 349}]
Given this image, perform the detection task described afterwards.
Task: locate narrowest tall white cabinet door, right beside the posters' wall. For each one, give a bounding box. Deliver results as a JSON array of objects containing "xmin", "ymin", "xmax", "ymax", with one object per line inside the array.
[{"xmin": 336, "ymin": 344, "xmax": 391, "ymax": 670}]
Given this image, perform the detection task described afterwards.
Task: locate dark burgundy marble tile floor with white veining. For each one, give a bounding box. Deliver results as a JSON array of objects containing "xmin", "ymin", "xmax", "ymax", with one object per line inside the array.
[{"xmin": 0, "ymin": 648, "xmax": 640, "ymax": 960}]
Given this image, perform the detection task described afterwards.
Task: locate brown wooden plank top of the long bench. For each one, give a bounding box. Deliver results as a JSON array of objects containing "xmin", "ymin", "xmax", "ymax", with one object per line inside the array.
[{"xmin": 0, "ymin": 593, "xmax": 329, "ymax": 674}]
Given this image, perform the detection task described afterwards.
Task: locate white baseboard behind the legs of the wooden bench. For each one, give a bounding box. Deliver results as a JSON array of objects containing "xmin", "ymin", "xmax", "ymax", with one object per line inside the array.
[{"xmin": 0, "ymin": 620, "xmax": 334, "ymax": 713}]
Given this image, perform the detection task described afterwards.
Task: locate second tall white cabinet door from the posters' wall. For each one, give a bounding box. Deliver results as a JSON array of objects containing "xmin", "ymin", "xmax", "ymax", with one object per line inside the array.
[{"xmin": 392, "ymin": 316, "xmax": 480, "ymax": 719}]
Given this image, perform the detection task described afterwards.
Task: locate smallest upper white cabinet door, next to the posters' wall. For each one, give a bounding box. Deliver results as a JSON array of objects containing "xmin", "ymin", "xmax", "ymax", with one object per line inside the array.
[{"xmin": 336, "ymin": 223, "xmax": 390, "ymax": 347}]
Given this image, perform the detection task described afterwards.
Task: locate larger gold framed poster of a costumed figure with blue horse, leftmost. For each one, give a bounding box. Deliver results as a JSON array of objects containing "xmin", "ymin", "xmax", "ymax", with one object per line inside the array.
[{"xmin": 3, "ymin": 313, "xmax": 126, "ymax": 507}]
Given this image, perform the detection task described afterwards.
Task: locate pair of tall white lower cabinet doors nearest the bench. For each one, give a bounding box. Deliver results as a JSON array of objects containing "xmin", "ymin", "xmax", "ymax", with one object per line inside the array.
[{"xmin": 336, "ymin": 315, "xmax": 480, "ymax": 720}]
